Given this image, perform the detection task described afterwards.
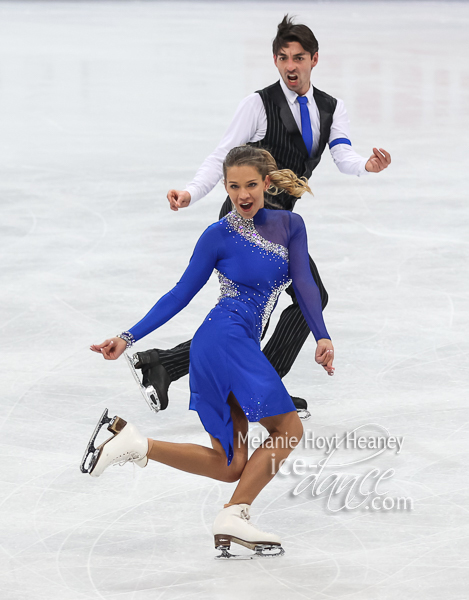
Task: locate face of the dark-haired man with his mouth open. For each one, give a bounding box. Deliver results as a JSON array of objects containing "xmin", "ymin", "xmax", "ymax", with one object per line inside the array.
[{"xmin": 274, "ymin": 42, "xmax": 318, "ymax": 96}]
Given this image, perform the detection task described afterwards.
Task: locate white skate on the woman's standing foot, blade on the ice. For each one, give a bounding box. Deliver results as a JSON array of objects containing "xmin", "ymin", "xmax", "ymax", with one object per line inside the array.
[{"xmin": 213, "ymin": 504, "xmax": 285, "ymax": 559}]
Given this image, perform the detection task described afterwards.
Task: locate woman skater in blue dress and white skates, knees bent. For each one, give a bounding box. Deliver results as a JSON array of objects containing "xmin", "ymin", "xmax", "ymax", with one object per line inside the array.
[{"xmin": 82, "ymin": 146, "xmax": 334, "ymax": 557}]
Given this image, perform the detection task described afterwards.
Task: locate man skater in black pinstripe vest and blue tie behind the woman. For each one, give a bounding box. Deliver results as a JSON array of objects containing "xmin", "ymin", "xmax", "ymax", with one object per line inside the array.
[{"xmin": 136, "ymin": 15, "xmax": 391, "ymax": 410}]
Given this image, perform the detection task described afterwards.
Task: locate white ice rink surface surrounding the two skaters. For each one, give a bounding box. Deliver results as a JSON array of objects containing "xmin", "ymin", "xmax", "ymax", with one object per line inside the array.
[{"xmin": 0, "ymin": 1, "xmax": 469, "ymax": 600}]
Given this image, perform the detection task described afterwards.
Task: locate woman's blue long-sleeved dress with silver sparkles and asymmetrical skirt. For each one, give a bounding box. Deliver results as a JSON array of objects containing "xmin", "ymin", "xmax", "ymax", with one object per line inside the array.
[{"xmin": 126, "ymin": 208, "xmax": 330, "ymax": 464}]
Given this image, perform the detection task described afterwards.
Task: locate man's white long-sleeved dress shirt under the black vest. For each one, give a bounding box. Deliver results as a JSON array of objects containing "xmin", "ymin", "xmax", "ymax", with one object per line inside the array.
[{"xmin": 185, "ymin": 79, "xmax": 368, "ymax": 204}]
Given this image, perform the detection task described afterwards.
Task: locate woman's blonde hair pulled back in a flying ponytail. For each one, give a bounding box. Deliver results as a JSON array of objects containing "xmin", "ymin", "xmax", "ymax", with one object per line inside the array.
[{"xmin": 223, "ymin": 146, "xmax": 313, "ymax": 198}]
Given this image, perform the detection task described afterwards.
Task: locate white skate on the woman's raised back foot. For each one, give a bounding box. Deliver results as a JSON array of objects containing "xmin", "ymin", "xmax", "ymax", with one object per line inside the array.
[{"xmin": 80, "ymin": 408, "xmax": 148, "ymax": 477}]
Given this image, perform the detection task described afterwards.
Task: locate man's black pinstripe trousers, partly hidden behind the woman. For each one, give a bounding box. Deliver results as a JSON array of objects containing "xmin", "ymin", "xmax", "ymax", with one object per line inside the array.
[{"xmin": 158, "ymin": 198, "xmax": 328, "ymax": 381}]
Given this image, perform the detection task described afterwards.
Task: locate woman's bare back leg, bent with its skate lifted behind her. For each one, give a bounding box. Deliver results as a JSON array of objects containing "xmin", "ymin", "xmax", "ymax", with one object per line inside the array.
[{"xmin": 147, "ymin": 394, "xmax": 248, "ymax": 482}]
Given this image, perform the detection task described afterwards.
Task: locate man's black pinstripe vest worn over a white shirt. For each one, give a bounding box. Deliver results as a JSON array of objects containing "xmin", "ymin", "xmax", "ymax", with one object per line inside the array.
[{"xmin": 251, "ymin": 81, "xmax": 337, "ymax": 210}]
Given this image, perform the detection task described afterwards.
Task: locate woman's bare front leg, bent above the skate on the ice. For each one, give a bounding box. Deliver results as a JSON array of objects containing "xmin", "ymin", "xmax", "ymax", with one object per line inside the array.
[{"xmin": 229, "ymin": 412, "xmax": 303, "ymax": 504}]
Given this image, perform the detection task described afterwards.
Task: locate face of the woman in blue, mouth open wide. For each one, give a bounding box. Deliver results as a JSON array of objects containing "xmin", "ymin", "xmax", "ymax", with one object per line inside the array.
[{"xmin": 225, "ymin": 165, "xmax": 270, "ymax": 219}]
